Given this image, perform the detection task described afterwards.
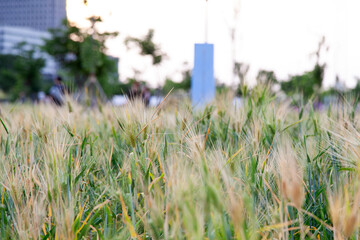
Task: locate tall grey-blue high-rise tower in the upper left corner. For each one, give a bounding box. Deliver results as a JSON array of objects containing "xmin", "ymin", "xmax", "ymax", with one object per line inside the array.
[{"xmin": 0, "ymin": 0, "xmax": 66, "ymax": 31}]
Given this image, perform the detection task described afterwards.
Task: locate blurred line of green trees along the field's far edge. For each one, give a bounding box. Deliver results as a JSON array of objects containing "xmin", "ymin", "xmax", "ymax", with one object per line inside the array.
[{"xmin": 0, "ymin": 17, "xmax": 360, "ymax": 101}]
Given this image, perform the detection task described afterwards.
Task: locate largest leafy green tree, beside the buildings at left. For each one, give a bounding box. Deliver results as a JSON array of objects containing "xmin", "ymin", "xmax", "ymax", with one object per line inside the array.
[{"xmin": 43, "ymin": 17, "xmax": 118, "ymax": 95}]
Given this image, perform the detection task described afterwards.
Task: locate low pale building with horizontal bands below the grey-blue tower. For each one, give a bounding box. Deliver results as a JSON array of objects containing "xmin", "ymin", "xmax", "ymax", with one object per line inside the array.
[{"xmin": 0, "ymin": 26, "xmax": 57, "ymax": 78}]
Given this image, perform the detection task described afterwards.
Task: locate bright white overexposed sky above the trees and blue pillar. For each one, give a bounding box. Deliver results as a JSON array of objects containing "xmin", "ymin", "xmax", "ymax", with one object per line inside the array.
[{"xmin": 67, "ymin": 0, "xmax": 360, "ymax": 87}]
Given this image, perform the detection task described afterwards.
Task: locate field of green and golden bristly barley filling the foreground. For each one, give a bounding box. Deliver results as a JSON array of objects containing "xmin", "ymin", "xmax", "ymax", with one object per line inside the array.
[{"xmin": 0, "ymin": 88, "xmax": 360, "ymax": 240}]
